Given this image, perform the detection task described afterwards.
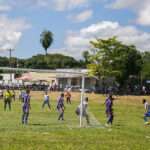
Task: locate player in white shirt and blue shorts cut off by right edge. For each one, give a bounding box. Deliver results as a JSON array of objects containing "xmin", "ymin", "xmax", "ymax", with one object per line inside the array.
[{"xmin": 143, "ymin": 99, "xmax": 150, "ymax": 124}]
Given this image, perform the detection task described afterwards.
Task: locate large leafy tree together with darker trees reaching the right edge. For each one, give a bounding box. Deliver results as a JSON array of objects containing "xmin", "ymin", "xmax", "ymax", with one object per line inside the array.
[{"xmin": 83, "ymin": 37, "xmax": 150, "ymax": 87}]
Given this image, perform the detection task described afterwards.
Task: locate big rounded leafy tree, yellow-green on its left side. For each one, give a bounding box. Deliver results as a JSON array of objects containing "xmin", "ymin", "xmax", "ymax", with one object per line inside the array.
[{"xmin": 88, "ymin": 37, "xmax": 142, "ymax": 84}]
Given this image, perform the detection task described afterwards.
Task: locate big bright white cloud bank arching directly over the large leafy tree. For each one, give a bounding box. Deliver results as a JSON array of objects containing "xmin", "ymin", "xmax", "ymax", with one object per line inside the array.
[{"xmin": 65, "ymin": 21, "xmax": 150, "ymax": 58}]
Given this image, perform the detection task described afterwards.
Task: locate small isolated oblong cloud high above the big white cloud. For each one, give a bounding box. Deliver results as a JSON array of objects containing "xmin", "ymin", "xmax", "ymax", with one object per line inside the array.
[{"xmin": 68, "ymin": 9, "xmax": 93, "ymax": 22}]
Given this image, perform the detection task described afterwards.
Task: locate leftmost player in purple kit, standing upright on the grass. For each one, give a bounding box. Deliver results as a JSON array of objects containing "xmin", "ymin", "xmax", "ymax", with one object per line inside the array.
[{"xmin": 22, "ymin": 89, "xmax": 31, "ymax": 124}]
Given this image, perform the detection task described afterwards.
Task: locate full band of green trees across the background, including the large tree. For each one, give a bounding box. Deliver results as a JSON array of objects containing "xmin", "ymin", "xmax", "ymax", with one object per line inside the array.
[{"xmin": 0, "ymin": 37, "xmax": 150, "ymax": 88}]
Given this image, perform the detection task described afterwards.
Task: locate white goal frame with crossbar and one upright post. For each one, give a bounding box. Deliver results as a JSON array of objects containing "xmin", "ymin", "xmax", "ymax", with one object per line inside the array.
[{"xmin": 0, "ymin": 67, "xmax": 88, "ymax": 127}]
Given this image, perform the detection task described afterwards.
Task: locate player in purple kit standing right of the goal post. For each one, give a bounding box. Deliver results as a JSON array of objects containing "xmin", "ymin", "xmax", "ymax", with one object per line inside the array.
[{"xmin": 105, "ymin": 95, "xmax": 114, "ymax": 126}]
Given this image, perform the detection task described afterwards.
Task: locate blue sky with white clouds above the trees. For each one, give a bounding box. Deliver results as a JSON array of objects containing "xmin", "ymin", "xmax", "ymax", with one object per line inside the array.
[{"xmin": 0, "ymin": 0, "xmax": 150, "ymax": 59}]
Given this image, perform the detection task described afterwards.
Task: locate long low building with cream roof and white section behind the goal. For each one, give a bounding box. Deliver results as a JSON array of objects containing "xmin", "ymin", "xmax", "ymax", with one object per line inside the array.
[{"xmin": 17, "ymin": 69, "xmax": 97, "ymax": 89}]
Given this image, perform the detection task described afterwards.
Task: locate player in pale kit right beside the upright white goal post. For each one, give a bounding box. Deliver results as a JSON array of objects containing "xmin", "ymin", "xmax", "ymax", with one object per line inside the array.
[{"xmin": 76, "ymin": 97, "xmax": 90, "ymax": 124}]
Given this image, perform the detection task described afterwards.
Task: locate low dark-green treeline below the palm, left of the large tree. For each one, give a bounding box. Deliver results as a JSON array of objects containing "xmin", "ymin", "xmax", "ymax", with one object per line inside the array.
[{"xmin": 0, "ymin": 54, "xmax": 86, "ymax": 69}]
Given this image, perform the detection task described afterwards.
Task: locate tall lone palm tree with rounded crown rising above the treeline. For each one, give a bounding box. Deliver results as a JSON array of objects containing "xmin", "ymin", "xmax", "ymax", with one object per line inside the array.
[{"xmin": 40, "ymin": 30, "xmax": 53, "ymax": 55}]
